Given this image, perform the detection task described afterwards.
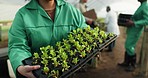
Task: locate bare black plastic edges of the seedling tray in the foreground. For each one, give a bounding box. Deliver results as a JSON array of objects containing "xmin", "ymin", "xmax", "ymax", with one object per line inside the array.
[{"xmin": 23, "ymin": 35, "xmax": 117, "ymax": 78}]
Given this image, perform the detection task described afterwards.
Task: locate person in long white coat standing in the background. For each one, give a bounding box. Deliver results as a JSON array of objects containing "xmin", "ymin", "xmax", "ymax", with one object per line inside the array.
[{"xmin": 105, "ymin": 6, "xmax": 120, "ymax": 52}]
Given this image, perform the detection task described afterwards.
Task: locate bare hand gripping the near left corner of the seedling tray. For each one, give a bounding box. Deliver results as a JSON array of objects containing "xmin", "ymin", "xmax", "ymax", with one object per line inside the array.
[{"xmin": 17, "ymin": 65, "xmax": 40, "ymax": 78}]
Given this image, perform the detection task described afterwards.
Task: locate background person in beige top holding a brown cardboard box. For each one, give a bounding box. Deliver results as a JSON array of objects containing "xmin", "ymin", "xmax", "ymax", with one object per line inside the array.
[{"xmin": 75, "ymin": 0, "xmax": 95, "ymax": 28}]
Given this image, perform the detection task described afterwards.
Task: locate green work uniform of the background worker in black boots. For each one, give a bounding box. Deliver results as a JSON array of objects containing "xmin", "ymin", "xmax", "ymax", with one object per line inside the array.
[{"xmin": 125, "ymin": 1, "xmax": 148, "ymax": 56}]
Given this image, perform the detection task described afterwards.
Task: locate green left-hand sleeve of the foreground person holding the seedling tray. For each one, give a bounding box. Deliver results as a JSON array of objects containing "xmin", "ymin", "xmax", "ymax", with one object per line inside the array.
[{"xmin": 8, "ymin": 12, "xmax": 31, "ymax": 73}]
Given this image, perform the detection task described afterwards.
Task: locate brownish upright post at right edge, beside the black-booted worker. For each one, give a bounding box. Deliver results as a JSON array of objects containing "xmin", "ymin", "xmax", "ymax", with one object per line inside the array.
[{"xmin": 138, "ymin": 26, "xmax": 148, "ymax": 78}]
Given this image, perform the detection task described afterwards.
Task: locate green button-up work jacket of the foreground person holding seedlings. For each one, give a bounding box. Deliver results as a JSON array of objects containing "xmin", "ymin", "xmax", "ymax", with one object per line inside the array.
[{"xmin": 8, "ymin": 0, "xmax": 87, "ymax": 73}]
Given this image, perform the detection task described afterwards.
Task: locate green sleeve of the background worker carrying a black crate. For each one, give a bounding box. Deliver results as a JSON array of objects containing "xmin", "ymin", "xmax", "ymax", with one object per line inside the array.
[{"xmin": 134, "ymin": 6, "xmax": 148, "ymax": 27}]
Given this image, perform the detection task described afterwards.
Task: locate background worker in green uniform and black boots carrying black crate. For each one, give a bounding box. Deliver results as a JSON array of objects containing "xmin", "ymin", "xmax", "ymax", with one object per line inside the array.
[{"xmin": 118, "ymin": 0, "xmax": 148, "ymax": 72}]
